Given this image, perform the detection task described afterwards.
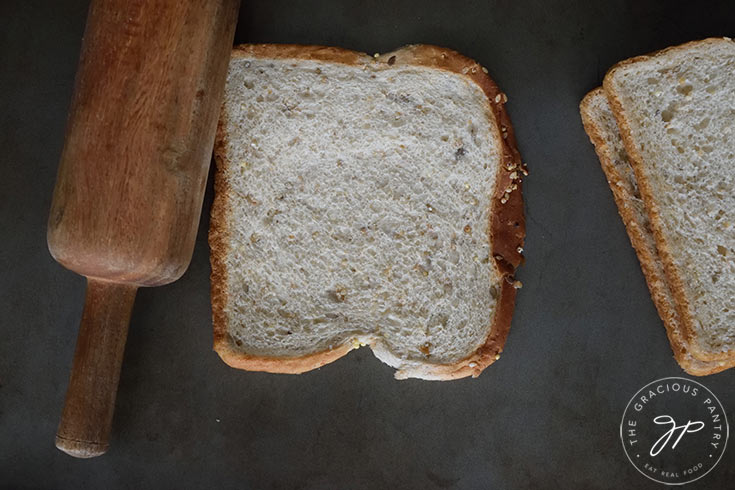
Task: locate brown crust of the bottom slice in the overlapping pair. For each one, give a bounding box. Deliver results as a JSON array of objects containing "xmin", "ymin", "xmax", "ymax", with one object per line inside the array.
[{"xmin": 579, "ymin": 87, "xmax": 735, "ymax": 376}]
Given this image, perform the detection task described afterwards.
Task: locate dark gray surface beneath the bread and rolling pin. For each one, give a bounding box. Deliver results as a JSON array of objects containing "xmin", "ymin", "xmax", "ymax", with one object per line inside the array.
[{"xmin": 0, "ymin": 0, "xmax": 735, "ymax": 489}]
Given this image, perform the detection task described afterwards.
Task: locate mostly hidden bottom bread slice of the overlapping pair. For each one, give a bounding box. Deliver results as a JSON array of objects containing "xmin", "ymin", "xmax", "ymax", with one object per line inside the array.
[{"xmin": 580, "ymin": 87, "xmax": 735, "ymax": 376}]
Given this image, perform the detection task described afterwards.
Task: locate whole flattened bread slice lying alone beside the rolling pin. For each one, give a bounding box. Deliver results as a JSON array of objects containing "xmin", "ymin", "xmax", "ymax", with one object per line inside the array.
[{"xmin": 209, "ymin": 45, "xmax": 527, "ymax": 380}]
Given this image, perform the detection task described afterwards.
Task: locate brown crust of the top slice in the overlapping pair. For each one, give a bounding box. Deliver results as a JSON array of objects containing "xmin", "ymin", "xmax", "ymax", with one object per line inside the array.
[{"xmin": 602, "ymin": 38, "xmax": 735, "ymax": 361}]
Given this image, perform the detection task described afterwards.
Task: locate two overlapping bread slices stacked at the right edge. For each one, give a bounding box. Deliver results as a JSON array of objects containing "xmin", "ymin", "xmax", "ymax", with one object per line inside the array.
[{"xmin": 580, "ymin": 38, "xmax": 735, "ymax": 376}]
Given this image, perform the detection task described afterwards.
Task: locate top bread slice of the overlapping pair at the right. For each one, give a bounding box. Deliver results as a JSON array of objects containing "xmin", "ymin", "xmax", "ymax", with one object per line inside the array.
[{"xmin": 603, "ymin": 39, "xmax": 735, "ymax": 360}]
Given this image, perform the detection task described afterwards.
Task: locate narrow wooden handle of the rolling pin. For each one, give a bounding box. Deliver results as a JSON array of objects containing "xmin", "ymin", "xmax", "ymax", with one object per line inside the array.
[{"xmin": 56, "ymin": 278, "xmax": 138, "ymax": 458}]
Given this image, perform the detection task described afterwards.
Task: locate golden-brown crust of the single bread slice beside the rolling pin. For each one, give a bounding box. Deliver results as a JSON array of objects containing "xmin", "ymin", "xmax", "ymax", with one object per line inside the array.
[{"xmin": 209, "ymin": 44, "xmax": 528, "ymax": 380}]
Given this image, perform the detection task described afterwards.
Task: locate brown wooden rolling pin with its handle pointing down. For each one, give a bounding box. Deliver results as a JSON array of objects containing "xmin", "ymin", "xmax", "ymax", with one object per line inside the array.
[{"xmin": 47, "ymin": 0, "xmax": 240, "ymax": 458}]
